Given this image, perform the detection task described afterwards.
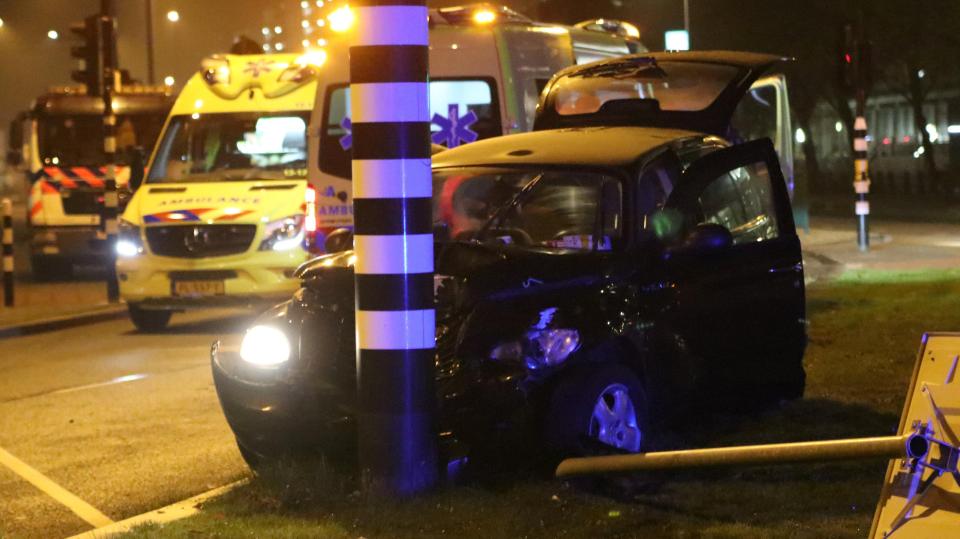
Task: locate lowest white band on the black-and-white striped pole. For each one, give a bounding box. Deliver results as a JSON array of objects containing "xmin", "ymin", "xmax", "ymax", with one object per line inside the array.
[{"xmin": 357, "ymin": 309, "xmax": 436, "ymax": 350}]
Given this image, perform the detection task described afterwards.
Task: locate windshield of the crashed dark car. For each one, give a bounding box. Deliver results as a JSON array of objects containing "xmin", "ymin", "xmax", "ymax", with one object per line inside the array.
[{"xmin": 433, "ymin": 168, "xmax": 621, "ymax": 250}]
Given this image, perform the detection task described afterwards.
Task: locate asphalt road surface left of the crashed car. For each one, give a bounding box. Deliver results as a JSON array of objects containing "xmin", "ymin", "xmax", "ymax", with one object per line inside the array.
[{"xmin": 0, "ymin": 311, "xmax": 255, "ymax": 537}]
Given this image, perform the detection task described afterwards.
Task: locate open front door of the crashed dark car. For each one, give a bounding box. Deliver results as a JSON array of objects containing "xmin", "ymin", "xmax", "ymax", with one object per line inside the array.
[{"xmin": 662, "ymin": 139, "xmax": 805, "ymax": 404}]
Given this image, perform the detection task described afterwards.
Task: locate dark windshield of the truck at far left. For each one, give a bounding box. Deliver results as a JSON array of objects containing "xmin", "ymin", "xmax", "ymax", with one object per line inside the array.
[{"xmin": 37, "ymin": 114, "xmax": 165, "ymax": 167}]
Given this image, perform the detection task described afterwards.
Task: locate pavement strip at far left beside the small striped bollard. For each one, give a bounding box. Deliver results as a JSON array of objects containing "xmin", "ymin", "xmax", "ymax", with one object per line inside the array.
[{"xmin": 0, "ymin": 281, "xmax": 126, "ymax": 338}]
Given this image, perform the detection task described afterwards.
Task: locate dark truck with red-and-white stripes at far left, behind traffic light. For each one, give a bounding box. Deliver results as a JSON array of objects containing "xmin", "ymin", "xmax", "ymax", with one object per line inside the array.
[{"xmin": 16, "ymin": 85, "xmax": 173, "ymax": 279}]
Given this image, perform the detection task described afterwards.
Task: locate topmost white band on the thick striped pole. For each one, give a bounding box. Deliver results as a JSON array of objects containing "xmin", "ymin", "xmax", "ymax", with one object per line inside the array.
[{"xmin": 351, "ymin": 6, "xmax": 429, "ymax": 47}]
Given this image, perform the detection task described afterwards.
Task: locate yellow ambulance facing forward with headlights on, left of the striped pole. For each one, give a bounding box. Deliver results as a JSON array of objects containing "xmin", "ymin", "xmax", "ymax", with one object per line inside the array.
[{"xmin": 117, "ymin": 52, "xmax": 324, "ymax": 331}]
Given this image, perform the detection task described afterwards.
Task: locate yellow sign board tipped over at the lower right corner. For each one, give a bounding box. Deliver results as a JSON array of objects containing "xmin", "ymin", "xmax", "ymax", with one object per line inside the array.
[{"xmin": 870, "ymin": 333, "xmax": 960, "ymax": 539}]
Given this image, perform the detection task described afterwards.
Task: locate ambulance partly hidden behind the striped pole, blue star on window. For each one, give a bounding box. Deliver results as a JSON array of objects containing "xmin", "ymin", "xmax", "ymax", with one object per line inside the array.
[{"xmin": 309, "ymin": 4, "xmax": 646, "ymax": 243}]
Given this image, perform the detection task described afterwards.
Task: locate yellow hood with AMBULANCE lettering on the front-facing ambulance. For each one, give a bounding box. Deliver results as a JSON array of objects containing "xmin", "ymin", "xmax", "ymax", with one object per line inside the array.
[{"xmin": 123, "ymin": 180, "xmax": 306, "ymax": 226}]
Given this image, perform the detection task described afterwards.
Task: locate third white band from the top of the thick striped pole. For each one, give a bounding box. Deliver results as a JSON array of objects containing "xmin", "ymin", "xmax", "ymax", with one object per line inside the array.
[{"xmin": 353, "ymin": 159, "xmax": 433, "ymax": 198}]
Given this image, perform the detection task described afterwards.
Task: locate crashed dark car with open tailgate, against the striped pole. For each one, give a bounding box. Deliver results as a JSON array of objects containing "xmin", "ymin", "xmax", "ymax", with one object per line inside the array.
[{"xmin": 212, "ymin": 53, "xmax": 806, "ymax": 465}]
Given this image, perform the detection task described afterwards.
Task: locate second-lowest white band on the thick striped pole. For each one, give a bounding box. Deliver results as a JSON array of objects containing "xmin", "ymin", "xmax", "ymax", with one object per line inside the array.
[{"xmin": 353, "ymin": 234, "xmax": 433, "ymax": 273}]
